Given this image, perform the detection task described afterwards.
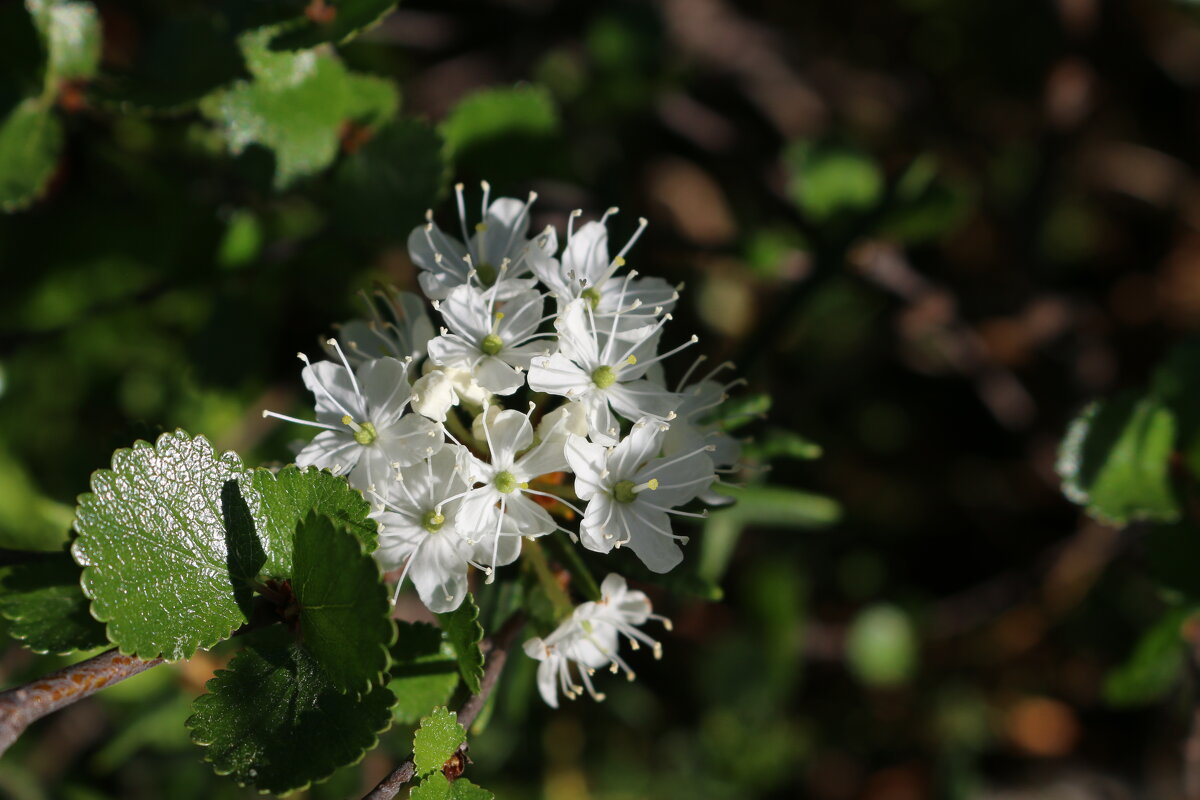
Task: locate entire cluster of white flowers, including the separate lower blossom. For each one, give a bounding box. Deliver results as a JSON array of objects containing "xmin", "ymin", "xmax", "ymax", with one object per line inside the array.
[{"xmin": 264, "ymin": 184, "xmax": 739, "ymax": 705}]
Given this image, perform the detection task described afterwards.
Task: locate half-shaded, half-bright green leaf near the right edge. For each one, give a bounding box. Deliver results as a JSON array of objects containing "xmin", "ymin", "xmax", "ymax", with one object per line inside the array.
[{"xmin": 1056, "ymin": 392, "xmax": 1180, "ymax": 524}]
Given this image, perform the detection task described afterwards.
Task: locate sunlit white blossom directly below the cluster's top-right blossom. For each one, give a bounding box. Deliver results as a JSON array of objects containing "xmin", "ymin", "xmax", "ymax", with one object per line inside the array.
[{"xmin": 529, "ymin": 300, "xmax": 696, "ymax": 444}]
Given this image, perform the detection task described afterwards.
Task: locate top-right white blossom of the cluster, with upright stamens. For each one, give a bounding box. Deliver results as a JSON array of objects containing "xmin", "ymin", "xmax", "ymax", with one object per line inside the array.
[{"xmin": 530, "ymin": 209, "xmax": 679, "ymax": 335}]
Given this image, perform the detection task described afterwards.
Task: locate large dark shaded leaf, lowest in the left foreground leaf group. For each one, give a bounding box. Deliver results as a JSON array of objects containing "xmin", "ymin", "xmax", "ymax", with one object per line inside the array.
[{"xmin": 187, "ymin": 630, "xmax": 392, "ymax": 794}]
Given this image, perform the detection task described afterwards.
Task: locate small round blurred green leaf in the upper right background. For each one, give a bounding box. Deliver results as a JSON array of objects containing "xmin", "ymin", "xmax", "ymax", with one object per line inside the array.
[{"xmin": 784, "ymin": 142, "xmax": 883, "ymax": 222}]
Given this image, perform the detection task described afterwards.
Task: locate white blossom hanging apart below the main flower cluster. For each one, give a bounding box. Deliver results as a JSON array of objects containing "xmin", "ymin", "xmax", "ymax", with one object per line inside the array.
[{"xmin": 524, "ymin": 575, "xmax": 671, "ymax": 709}]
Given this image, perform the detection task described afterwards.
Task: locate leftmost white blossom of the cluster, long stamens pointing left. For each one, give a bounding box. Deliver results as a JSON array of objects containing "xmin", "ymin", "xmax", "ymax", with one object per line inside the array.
[{"xmin": 263, "ymin": 339, "xmax": 444, "ymax": 491}]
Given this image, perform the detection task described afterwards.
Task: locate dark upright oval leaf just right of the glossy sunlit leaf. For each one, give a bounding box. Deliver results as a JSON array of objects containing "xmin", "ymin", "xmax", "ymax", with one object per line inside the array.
[{"xmin": 292, "ymin": 513, "xmax": 396, "ymax": 692}]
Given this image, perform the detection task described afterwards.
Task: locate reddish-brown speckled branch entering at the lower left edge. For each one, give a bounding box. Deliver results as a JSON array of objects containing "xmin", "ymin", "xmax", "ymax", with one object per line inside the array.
[{"xmin": 0, "ymin": 648, "xmax": 162, "ymax": 754}]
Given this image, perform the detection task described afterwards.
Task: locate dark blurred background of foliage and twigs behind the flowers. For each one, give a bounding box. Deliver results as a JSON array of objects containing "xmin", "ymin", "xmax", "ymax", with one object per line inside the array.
[{"xmin": 0, "ymin": 0, "xmax": 1200, "ymax": 800}]
